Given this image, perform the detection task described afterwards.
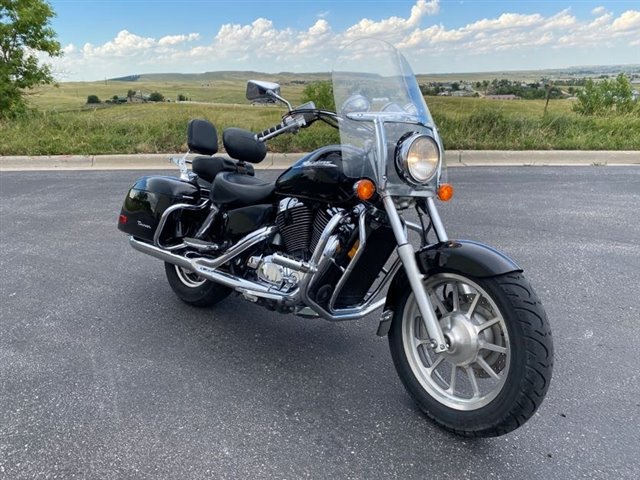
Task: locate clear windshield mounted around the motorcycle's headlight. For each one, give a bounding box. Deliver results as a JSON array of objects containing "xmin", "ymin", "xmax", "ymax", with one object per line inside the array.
[{"xmin": 332, "ymin": 39, "xmax": 440, "ymax": 195}]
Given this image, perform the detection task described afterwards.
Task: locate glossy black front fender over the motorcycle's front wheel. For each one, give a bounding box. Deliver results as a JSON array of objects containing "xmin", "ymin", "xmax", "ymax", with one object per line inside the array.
[{"xmin": 385, "ymin": 240, "xmax": 522, "ymax": 310}]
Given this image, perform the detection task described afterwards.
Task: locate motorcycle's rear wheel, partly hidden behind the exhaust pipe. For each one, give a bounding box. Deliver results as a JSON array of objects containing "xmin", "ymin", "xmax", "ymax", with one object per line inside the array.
[{"xmin": 164, "ymin": 262, "xmax": 231, "ymax": 307}]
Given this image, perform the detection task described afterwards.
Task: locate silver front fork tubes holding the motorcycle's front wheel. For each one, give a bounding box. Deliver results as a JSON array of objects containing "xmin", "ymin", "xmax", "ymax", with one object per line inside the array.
[{"xmin": 382, "ymin": 195, "xmax": 447, "ymax": 353}]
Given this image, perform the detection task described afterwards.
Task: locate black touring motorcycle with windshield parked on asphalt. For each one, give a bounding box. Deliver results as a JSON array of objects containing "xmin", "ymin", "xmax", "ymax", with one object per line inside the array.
[{"xmin": 118, "ymin": 39, "xmax": 553, "ymax": 436}]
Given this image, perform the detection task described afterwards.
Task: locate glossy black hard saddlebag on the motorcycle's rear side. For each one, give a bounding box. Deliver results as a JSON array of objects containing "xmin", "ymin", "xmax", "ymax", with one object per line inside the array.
[{"xmin": 118, "ymin": 176, "xmax": 200, "ymax": 241}]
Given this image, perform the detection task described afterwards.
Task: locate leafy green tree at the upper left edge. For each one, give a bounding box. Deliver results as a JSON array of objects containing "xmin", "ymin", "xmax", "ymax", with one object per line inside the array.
[{"xmin": 0, "ymin": 0, "xmax": 62, "ymax": 117}]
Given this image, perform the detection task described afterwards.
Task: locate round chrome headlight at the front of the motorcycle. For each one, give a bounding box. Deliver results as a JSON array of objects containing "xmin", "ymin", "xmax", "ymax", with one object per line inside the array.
[{"xmin": 396, "ymin": 133, "xmax": 440, "ymax": 185}]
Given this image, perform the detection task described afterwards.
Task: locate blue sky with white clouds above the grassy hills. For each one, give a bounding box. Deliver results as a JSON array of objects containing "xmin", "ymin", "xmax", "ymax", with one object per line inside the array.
[{"xmin": 50, "ymin": 0, "xmax": 640, "ymax": 80}]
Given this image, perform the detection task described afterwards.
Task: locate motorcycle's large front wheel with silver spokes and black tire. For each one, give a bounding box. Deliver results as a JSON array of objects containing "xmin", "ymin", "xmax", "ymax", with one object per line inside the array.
[{"xmin": 389, "ymin": 272, "xmax": 553, "ymax": 437}]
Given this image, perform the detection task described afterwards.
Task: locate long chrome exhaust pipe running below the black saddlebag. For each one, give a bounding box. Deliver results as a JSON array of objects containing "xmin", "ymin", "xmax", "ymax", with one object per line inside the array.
[{"xmin": 129, "ymin": 237, "xmax": 298, "ymax": 302}]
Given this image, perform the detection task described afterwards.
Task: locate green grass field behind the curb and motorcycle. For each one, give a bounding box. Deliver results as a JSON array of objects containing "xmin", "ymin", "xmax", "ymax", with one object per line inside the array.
[{"xmin": 0, "ymin": 77, "xmax": 640, "ymax": 155}]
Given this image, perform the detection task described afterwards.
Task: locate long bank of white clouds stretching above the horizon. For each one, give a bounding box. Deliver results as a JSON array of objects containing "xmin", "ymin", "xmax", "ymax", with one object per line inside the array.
[{"xmin": 51, "ymin": 0, "xmax": 640, "ymax": 79}]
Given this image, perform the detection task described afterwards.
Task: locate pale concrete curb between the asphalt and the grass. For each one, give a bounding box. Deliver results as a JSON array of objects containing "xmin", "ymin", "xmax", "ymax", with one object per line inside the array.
[{"xmin": 0, "ymin": 150, "xmax": 640, "ymax": 172}]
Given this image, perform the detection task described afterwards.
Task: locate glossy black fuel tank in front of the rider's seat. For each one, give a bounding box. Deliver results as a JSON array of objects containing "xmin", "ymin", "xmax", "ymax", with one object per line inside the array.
[{"xmin": 275, "ymin": 145, "xmax": 373, "ymax": 205}]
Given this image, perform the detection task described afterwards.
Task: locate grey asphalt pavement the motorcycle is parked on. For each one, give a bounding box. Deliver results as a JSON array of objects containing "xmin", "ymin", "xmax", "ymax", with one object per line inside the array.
[{"xmin": 0, "ymin": 167, "xmax": 640, "ymax": 479}]
